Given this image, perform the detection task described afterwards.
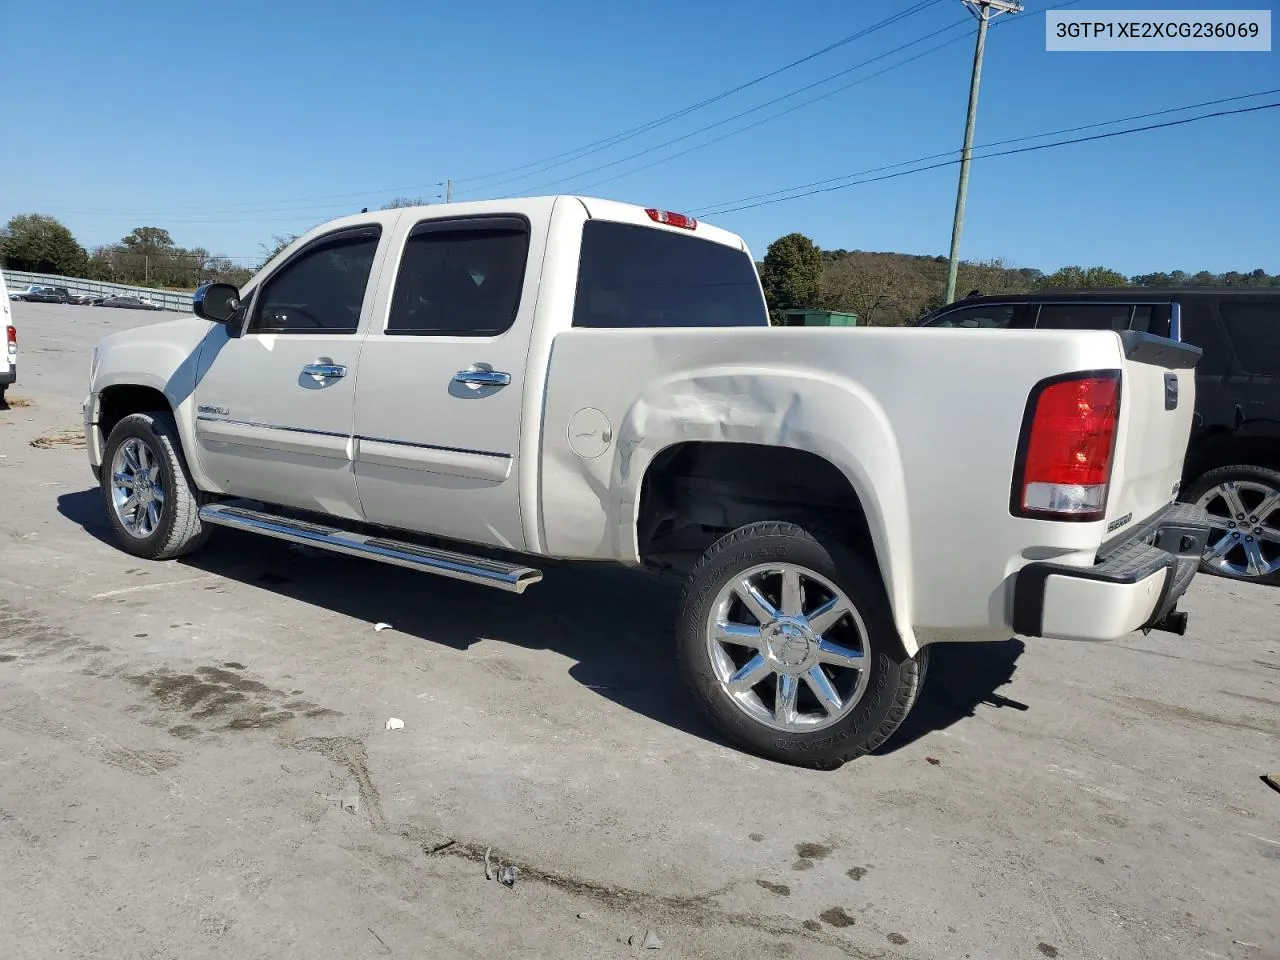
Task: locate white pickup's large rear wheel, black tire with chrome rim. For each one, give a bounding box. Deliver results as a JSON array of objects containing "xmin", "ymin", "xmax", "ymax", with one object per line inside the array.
[{"xmin": 676, "ymin": 521, "xmax": 928, "ymax": 769}]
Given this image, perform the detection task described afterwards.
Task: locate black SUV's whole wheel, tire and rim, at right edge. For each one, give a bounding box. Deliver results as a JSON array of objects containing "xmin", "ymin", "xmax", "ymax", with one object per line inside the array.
[{"xmin": 1183, "ymin": 463, "xmax": 1280, "ymax": 585}]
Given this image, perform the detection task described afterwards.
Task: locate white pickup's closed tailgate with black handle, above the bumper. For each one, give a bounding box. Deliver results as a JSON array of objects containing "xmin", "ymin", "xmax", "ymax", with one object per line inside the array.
[{"xmin": 1106, "ymin": 332, "xmax": 1201, "ymax": 531}]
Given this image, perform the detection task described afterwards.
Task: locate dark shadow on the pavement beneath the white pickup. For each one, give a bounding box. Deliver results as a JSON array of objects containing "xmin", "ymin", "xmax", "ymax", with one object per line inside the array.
[{"xmin": 58, "ymin": 489, "xmax": 1025, "ymax": 754}]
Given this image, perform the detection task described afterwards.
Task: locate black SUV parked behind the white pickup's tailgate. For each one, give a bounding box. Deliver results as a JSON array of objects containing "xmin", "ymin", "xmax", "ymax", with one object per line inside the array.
[{"xmin": 918, "ymin": 287, "xmax": 1280, "ymax": 584}]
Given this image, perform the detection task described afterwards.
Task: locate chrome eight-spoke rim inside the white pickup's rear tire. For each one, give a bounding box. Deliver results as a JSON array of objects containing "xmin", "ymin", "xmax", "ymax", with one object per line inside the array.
[{"xmin": 707, "ymin": 563, "xmax": 870, "ymax": 732}]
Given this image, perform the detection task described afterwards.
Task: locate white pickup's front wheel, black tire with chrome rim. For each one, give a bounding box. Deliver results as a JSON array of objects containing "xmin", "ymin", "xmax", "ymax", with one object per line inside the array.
[{"xmin": 99, "ymin": 411, "xmax": 211, "ymax": 559}]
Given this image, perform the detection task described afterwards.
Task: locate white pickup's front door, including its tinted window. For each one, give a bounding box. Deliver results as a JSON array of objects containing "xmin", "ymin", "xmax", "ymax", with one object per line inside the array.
[{"xmin": 196, "ymin": 225, "xmax": 381, "ymax": 520}]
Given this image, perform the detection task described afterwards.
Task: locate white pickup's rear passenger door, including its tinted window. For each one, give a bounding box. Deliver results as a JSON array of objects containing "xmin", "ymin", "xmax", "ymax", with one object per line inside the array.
[{"xmin": 355, "ymin": 212, "xmax": 552, "ymax": 549}]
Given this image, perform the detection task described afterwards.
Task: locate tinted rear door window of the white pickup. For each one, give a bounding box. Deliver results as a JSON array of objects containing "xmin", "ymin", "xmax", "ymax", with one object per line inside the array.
[{"xmin": 387, "ymin": 216, "xmax": 529, "ymax": 337}]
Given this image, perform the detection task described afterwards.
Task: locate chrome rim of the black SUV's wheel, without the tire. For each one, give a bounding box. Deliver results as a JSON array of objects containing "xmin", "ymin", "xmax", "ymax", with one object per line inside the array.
[{"xmin": 1197, "ymin": 480, "xmax": 1280, "ymax": 577}]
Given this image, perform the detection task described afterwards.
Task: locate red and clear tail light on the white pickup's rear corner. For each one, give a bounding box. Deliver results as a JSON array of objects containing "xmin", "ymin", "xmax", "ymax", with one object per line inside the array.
[{"xmin": 1009, "ymin": 370, "xmax": 1120, "ymax": 521}]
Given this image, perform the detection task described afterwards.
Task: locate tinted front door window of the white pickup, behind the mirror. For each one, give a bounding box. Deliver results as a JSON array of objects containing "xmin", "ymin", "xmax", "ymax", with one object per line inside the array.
[{"xmin": 250, "ymin": 227, "xmax": 381, "ymax": 333}]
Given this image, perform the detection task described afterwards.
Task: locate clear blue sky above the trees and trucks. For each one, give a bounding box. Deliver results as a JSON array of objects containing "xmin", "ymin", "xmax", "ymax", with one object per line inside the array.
[{"xmin": 0, "ymin": 0, "xmax": 1280, "ymax": 274}]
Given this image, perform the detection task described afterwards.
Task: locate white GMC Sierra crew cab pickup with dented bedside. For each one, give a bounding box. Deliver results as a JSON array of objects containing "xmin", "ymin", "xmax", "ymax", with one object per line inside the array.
[{"xmin": 84, "ymin": 196, "xmax": 1208, "ymax": 767}]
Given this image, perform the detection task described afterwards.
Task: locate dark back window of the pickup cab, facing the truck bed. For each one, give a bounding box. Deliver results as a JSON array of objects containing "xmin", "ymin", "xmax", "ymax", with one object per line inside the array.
[{"xmin": 573, "ymin": 220, "xmax": 769, "ymax": 328}]
